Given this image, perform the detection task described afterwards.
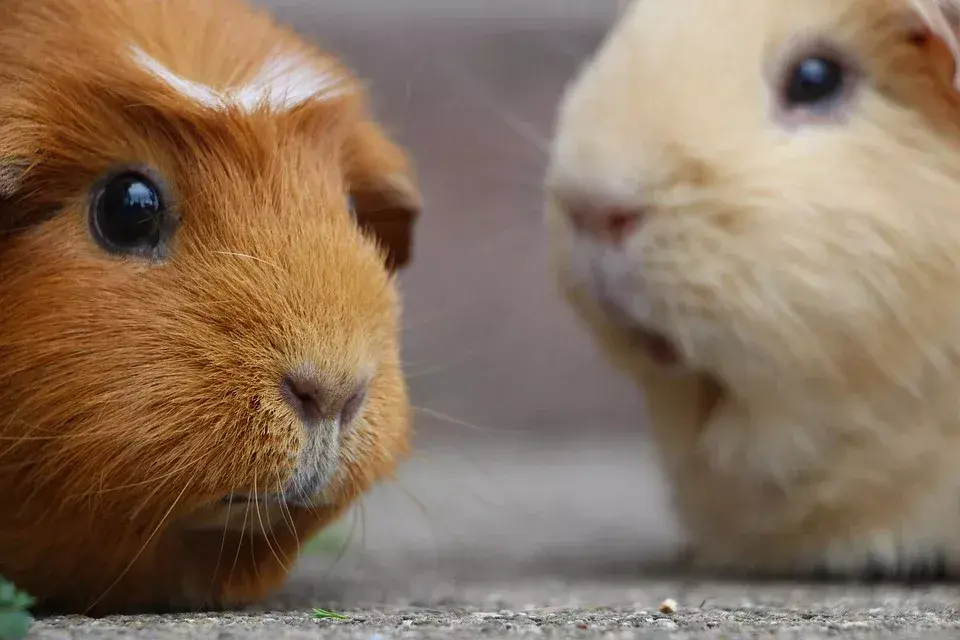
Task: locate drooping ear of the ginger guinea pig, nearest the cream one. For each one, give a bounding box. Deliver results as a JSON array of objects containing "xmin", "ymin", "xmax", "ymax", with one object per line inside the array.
[{"xmin": 347, "ymin": 122, "xmax": 423, "ymax": 271}]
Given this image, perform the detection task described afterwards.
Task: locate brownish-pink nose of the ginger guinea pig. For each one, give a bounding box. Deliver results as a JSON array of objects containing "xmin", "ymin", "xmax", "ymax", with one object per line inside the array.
[{"xmin": 281, "ymin": 367, "xmax": 366, "ymax": 427}]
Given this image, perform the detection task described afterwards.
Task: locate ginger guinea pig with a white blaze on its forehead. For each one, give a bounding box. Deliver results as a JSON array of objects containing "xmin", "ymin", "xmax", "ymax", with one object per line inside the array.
[{"xmin": 0, "ymin": 0, "xmax": 421, "ymax": 615}]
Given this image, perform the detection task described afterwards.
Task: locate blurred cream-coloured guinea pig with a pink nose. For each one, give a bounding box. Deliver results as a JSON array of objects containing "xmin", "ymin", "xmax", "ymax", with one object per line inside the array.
[{"xmin": 544, "ymin": 0, "xmax": 960, "ymax": 580}]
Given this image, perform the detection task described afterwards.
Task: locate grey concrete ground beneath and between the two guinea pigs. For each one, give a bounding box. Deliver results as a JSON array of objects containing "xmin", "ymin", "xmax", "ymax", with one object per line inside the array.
[{"xmin": 32, "ymin": 433, "xmax": 960, "ymax": 640}]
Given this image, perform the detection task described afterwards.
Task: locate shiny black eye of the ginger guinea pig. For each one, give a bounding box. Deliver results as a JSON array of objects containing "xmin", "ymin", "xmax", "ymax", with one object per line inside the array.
[{"xmin": 92, "ymin": 171, "xmax": 166, "ymax": 254}]
